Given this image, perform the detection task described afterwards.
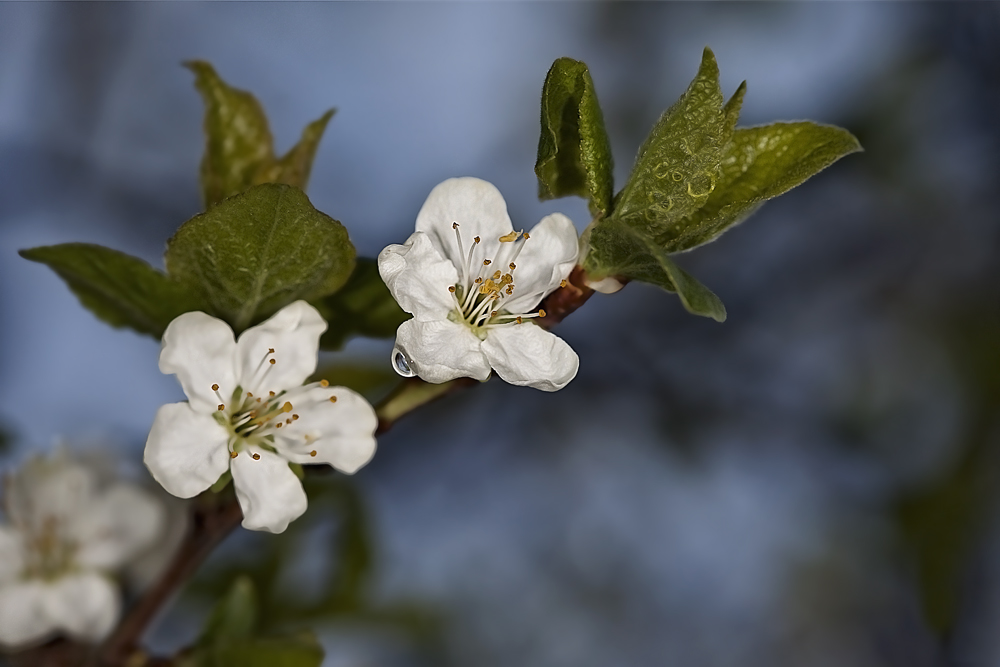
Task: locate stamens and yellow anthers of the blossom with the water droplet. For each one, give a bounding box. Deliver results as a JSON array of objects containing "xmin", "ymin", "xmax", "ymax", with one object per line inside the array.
[{"xmin": 448, "ymin": 222, "xmax": 565, "ymax": 338}]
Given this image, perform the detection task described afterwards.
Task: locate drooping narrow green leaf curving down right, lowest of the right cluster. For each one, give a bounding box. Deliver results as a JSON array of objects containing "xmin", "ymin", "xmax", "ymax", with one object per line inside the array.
[{"xmin": 584, "ymin": 220, "xmax": 726, "ymax": 322}]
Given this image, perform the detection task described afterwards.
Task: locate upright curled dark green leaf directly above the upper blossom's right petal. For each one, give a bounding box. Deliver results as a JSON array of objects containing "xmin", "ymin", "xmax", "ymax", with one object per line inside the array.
[{"xmin": 535, "ymin": 58, "xmax": 614, "ymax": 216}]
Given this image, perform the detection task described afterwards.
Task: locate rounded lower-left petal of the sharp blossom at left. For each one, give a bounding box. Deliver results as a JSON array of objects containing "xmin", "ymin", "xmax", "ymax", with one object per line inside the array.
[{"xmin": 143, "ymin": 403, "xmax": 229, "ymax": 498}]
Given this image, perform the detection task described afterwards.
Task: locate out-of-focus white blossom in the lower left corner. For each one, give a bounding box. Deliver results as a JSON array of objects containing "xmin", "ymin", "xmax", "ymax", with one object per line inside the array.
[{"xmin": 0, "ymin": 451, "xmax": 163, "ymax": 648}]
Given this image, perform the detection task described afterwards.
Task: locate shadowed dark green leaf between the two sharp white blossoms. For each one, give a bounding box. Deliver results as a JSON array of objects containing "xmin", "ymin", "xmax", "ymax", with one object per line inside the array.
[{"xmin": 316, "ymin": 257, "xmax": 410, "ymax": 350}]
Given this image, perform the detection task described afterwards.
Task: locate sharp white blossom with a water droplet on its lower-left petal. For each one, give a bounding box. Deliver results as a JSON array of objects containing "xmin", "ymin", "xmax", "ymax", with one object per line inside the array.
[{"xmin": 378, "ymin": 178, "xmax": 580, "ymax": 391}]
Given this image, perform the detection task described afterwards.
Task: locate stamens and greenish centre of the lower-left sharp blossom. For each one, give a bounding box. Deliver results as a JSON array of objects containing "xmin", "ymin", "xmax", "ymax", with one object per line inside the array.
[{"xmin": 212, "ymin": 348, "xmax": 337, "ymax": 459}]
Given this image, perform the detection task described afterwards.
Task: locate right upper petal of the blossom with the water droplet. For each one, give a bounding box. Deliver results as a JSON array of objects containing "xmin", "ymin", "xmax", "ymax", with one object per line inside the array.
[{"xmin": 503, "ymin": 213, "xmax": 580, "ymax": 313}]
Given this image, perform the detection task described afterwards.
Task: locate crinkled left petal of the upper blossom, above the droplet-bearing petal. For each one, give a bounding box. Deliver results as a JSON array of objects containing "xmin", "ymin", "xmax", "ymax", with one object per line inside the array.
[{"xmin": 378, "ymin": 232, "xmax": 458, "ymax": 320}]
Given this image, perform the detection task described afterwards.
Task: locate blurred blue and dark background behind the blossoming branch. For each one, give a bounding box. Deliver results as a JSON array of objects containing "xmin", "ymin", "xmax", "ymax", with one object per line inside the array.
[{"xmin": 0, "ymin": 3, "xmax": 1000, "ymax": 667}]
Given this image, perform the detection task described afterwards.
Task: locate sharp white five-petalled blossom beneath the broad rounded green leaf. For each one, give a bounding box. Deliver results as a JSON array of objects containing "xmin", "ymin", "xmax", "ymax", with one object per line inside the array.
[{"xmin": 144, "ymin": 301, "xmax": 378, "ymax": 533}]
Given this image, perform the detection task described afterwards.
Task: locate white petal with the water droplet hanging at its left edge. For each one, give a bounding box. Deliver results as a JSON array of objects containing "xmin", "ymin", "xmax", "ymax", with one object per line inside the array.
[{"xmin": 396, "ymin": 319, "xmax": 490, "ymax": 384}]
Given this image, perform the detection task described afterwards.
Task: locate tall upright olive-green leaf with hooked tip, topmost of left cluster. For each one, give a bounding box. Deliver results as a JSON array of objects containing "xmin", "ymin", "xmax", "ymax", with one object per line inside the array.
[{"xmin": 185, "ymin": 60, "xmax": 274, "ymax": 207}]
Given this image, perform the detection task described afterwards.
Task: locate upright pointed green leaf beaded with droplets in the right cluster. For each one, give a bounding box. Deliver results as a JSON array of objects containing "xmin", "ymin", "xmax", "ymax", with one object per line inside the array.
[{"xmin": 612, "ymin": 48, "xmax": 724, "ymax": 236}]
